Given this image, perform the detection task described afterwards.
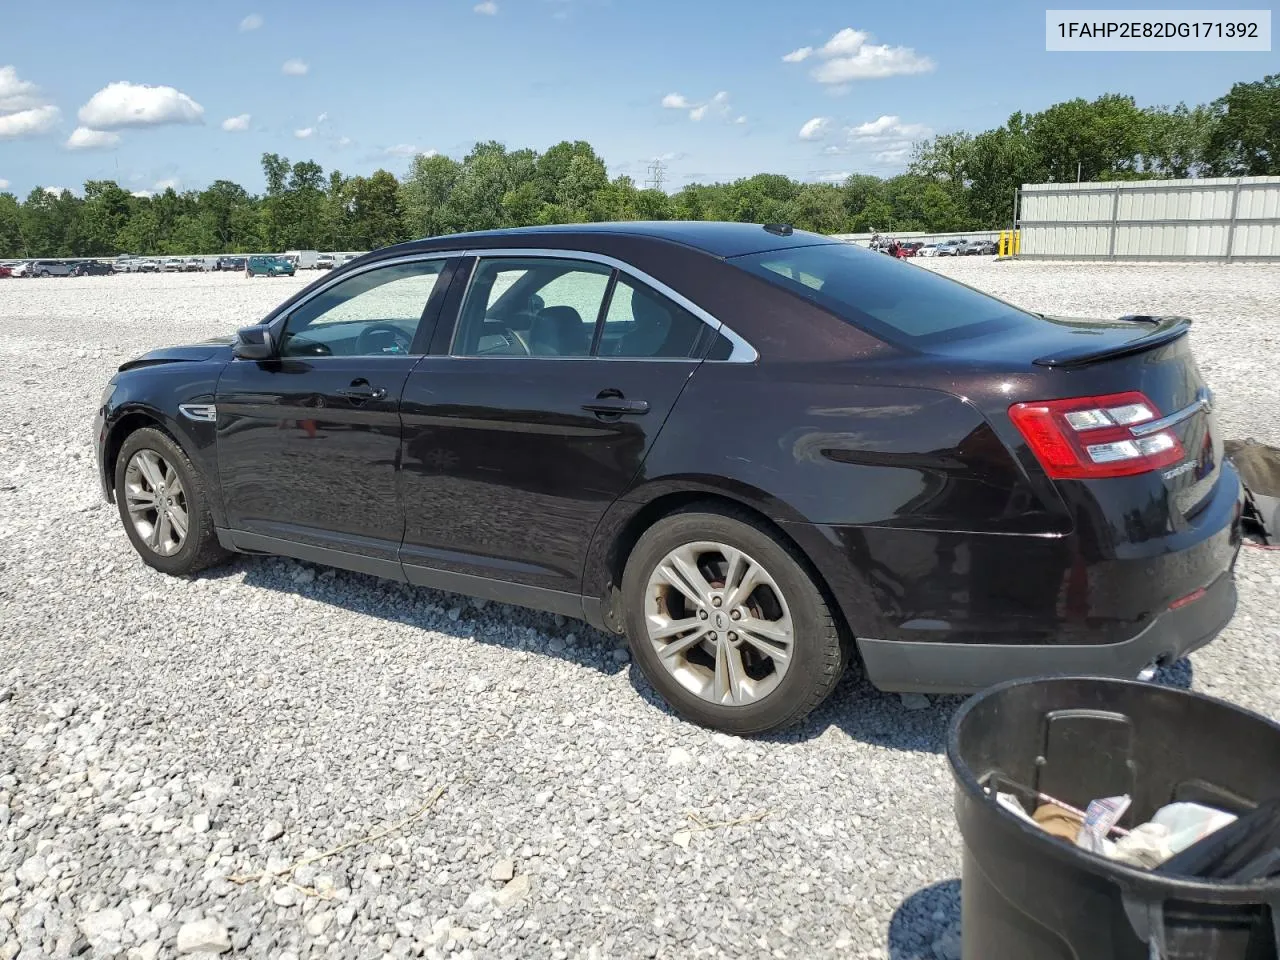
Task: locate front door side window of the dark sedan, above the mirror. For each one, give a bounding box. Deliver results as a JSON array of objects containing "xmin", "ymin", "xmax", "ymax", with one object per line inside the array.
[{"xmin": 280, "ymin": 260, "xmax": 444, "ymax": 357}]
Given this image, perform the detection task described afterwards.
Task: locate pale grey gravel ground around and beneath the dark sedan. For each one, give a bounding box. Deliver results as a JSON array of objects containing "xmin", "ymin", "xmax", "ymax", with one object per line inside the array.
[{"xmin": 0, "ymin": 259, "xmax": 1280, "ymax": 960}]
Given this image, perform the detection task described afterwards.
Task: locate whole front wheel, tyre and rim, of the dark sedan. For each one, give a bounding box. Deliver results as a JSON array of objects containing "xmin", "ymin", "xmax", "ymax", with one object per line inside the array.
[{"xmin": 115, "ymin": 428, "xmax": 230, "ymax": 576}]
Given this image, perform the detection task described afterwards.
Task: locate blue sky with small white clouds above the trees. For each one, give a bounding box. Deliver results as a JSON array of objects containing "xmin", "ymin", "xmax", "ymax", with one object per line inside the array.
[{"xmin": 0, "ymin": 0, "xmax": 1277, "ymax": 196}]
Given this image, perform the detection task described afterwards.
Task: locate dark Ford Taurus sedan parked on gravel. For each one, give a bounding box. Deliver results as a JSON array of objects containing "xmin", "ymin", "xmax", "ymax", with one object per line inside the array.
[{"xmin": 96, "ymin": 223, "xmax": 1242, "ymax": 733}]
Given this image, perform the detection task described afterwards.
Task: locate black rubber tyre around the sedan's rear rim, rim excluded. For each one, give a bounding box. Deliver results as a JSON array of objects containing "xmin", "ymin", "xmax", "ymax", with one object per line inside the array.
[{"xmin": 622, "ymin": 504, "xmax": 847, "ymax": 735}]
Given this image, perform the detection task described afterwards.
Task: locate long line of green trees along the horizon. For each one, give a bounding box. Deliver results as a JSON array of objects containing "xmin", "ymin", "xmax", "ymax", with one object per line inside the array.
[{"xmin": 0, "ymin": 74, "xmax": 1280, "ymax": 257}]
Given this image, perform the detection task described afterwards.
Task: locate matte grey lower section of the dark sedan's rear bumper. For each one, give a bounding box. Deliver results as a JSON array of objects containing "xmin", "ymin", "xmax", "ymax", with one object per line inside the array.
[{"xmin": 858, "ymin": 570, "xmax": 1236, "ymax": 694}]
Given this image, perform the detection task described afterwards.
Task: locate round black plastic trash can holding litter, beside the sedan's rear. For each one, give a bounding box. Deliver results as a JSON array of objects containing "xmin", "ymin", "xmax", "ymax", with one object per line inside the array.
[{"xmin": 947, "ymin": 677, "xmax": 1280, "ymax": 960}]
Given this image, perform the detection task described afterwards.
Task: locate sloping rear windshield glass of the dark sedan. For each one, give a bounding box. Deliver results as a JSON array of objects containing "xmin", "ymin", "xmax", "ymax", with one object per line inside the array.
[{"xmin": 728, "ymin": 243, "xmax": 1038, "ymax": 346}]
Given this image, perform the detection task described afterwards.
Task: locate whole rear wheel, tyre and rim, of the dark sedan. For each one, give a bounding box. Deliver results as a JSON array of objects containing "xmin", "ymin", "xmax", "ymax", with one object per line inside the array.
[{"xmin": 622, "ymin": 508, "xmax": 845, "ymax": 733}]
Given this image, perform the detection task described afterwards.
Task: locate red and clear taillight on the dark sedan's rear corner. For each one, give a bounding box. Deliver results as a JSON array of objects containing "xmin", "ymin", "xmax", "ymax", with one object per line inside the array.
[{"xmin": 1009, "ymin": 393, "xmax": 1185, "ymax": 480}]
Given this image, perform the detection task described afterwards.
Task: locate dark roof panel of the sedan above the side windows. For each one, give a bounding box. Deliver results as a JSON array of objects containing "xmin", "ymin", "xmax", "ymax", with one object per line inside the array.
[{"xmin": 397, "ymin": 220, "xmax": 840, "ymax": 257}]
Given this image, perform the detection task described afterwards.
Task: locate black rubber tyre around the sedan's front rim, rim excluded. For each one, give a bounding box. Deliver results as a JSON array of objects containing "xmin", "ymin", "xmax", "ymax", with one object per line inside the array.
[{"xmin": 115, "ymin": 426, "xmax": 232, "ymax": 576}]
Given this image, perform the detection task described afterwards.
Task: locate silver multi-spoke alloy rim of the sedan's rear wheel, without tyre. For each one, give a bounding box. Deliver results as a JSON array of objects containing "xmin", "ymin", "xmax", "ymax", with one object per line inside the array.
[{"xmin": 645, "ymin": 541, "xmax": 795, "ymax": 707}]
